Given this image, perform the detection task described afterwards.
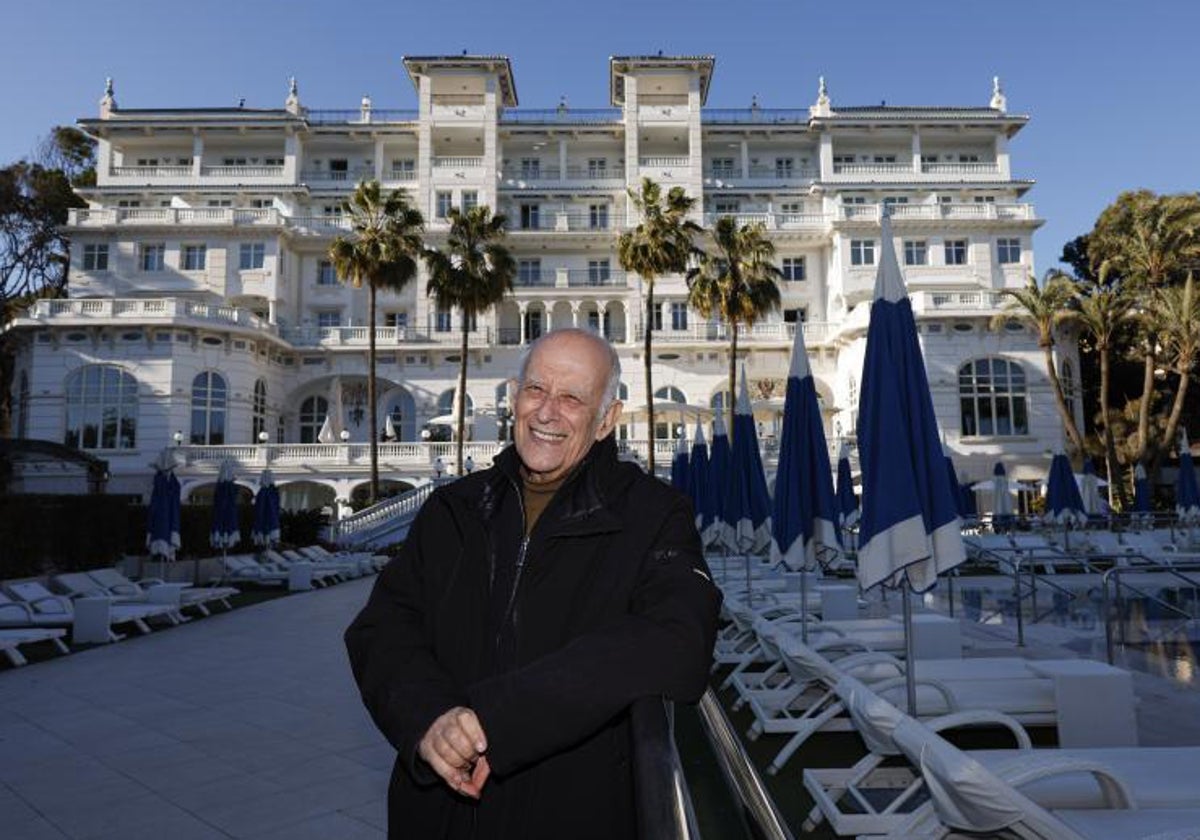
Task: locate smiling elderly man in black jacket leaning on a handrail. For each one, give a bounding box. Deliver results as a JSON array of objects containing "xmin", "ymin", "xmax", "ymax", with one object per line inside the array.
[{"xmin": 346, "ymin": 330, "xmax": 720, "ymax": 840}]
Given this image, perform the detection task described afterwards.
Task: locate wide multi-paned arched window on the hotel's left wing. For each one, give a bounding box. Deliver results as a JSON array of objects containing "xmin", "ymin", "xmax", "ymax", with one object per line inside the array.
[{"xmin": 64, "ymin": 365, "xmax": 138, "ymax": 449}]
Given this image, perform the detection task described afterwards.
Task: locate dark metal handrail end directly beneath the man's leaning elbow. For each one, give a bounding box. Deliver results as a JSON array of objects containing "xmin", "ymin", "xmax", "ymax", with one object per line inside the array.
[{"xmin": 630, "ymin": 697, "xmax": 700, "ymax": 840}]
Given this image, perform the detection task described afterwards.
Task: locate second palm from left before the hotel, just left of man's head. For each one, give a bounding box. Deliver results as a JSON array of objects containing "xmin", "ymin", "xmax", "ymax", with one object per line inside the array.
[{"xmin": 425, "ymin": 205, "xmax": 517, "ymax": 475}]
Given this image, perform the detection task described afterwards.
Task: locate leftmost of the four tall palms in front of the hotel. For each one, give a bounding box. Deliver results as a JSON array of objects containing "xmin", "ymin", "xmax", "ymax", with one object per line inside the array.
[{"xmin": 329, "ymin": 181, "xmax": 425, "ymax": 504}]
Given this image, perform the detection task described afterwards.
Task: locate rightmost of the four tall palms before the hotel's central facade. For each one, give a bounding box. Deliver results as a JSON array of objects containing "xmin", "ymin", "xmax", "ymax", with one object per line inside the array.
[{"xmin": 688, "ymin": 216, "xmax": 782, "ymax": 431}]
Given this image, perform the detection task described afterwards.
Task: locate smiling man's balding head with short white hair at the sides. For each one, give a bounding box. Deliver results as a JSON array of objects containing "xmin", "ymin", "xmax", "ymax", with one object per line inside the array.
[{"xmin": 514, "ymin": 334, "xmax": 620, "ymax": 484}]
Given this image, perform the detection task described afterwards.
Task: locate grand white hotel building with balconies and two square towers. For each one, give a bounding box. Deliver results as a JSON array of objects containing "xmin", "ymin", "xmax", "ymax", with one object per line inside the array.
[{"xmin": 0, "ymin": 55, "xmax": 1078, "ymax": 505}]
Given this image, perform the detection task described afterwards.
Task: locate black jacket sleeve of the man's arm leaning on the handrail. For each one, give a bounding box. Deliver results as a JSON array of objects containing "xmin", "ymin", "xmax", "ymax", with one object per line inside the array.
[{"xmin": 468, "ymin": 498, "xmax": 721, "ymax": 775}]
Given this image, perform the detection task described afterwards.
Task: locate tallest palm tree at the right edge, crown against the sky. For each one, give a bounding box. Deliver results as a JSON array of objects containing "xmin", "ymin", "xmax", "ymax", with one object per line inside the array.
[{"xmin": 1088, "ymin": 190, "xmax": 1200, "ymax": 461}]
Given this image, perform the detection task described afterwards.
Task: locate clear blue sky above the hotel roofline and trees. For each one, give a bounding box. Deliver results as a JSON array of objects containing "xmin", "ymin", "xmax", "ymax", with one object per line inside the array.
[{"xmin": 0, "ymin": 0, "xmax": 1200, "ymax": 271}]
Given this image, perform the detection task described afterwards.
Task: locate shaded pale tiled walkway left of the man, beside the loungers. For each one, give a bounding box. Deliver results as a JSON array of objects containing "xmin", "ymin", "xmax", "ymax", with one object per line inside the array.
[{"xmin": 0, "ymin": 578, "xmax": 392, "ymax": 840}]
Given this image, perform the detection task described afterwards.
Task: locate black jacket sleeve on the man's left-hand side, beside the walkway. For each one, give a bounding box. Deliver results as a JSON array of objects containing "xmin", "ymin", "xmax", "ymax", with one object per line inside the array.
[{"xmin": 346, "ymin": 493, "xmax": 467, "ymax": 782}]
